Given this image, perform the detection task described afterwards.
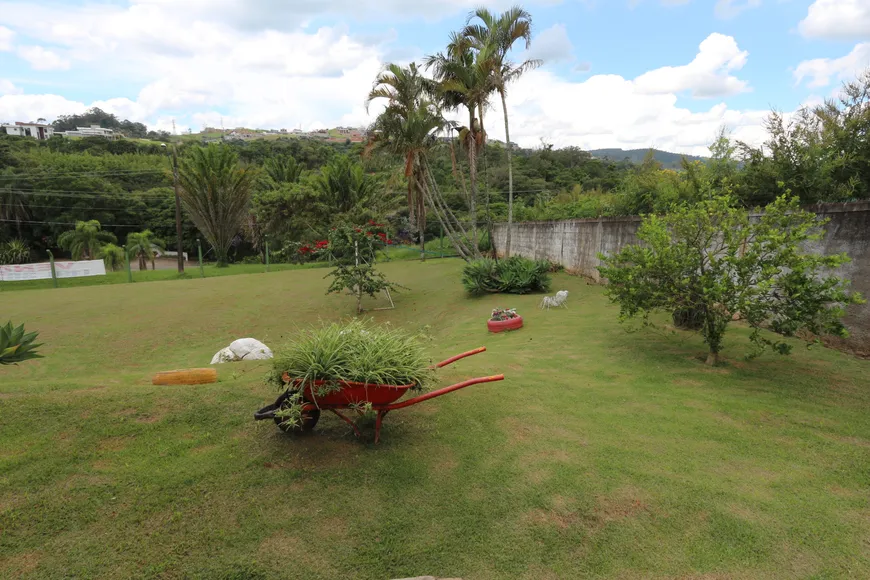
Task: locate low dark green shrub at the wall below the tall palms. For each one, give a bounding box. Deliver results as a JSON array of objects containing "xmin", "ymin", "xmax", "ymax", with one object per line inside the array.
[{"xmin": 462, "ymin": 256, "xmax": 550, "ymax": 295}]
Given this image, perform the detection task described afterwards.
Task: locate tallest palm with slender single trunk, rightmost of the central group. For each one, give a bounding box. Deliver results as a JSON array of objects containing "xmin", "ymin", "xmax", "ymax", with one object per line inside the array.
[{"xmin": 463, "ymin": 6, "xmax": 543, "ymax": 257}]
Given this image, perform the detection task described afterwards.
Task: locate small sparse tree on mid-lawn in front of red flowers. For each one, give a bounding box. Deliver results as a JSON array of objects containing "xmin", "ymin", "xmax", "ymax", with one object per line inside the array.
[{"xmin": 325, "ymin": 224, "xmax": 402, "ymax": 314}]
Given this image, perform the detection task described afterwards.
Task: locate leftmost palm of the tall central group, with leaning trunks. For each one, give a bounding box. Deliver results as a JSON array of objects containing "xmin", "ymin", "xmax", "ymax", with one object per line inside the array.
[{"xmin": 365, "ymin": 65, "xmax": 478, "ymax": 259}]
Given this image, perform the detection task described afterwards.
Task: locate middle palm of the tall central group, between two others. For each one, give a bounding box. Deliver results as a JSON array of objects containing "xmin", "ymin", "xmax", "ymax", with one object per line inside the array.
[{"xmin": 425, "ymin": 33, "xmax": 495, "ymax": 250}]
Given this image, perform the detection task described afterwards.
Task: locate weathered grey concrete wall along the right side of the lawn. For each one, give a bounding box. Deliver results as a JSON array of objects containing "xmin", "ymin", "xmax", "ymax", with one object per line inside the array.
[{"xmin": 494, "ymin": 202, "xmax": 870, "ymax": 355}]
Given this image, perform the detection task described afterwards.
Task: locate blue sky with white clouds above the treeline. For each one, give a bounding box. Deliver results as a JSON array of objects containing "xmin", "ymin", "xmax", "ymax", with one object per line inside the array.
[{"xmin": 0, "ymin": 0, "xmax": 870, "ymax": 153}]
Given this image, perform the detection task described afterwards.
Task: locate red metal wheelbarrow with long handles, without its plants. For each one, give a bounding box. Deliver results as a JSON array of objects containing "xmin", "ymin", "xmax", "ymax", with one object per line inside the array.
[{"xmin": 254, "ymin": 347, "xmax": 504, "ymax": 443}]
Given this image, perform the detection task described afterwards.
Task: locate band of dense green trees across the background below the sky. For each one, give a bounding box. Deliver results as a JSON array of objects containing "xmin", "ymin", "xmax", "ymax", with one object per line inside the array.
[{"xmin": 0, "ymin": 69, "xmax": 870, "ymax": 261}]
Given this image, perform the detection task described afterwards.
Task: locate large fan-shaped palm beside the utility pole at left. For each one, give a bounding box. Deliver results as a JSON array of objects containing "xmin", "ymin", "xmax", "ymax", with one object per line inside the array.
[{"xmin": 178, "ymin": 144, "xmax": 254, "ymax": 267}]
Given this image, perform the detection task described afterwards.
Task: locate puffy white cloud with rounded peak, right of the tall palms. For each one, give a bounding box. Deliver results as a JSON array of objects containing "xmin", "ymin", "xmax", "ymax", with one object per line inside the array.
[{"xmin": 635, "ymin": 33, "xmax": 749, "ymax": 98}]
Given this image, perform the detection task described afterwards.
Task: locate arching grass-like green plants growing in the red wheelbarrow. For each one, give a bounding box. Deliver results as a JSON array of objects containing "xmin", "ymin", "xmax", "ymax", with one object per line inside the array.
[{"xmin": 267, "ymin": 320, "xmax": 434, "ymax": 388}]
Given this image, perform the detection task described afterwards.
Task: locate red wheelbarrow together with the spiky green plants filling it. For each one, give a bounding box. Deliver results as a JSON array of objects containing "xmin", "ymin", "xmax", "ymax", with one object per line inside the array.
[{"xmin": 254, "ymin": 321, "xmax": 504, "ymax": 443}]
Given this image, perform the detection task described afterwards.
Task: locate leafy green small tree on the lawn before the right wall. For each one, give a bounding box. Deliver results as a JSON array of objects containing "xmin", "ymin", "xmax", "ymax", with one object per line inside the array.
[{"xmin": 599, "ymin": 196, "xmax": 862, "ymax": 365}]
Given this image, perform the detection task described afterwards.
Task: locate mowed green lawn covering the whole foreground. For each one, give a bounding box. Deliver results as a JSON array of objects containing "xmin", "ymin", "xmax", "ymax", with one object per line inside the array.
[{"xmin": 0, "ymin": 260, "xmax": 870, "ymax": 580}]
